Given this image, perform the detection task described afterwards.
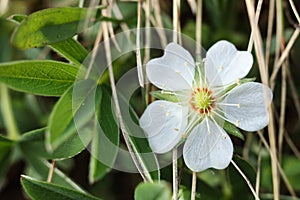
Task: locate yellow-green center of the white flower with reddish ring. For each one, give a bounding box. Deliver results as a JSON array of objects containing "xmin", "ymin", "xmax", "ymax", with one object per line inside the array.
[{"xmin": 190, "ymin": 87, "xmax": 215, "ymax": 114}]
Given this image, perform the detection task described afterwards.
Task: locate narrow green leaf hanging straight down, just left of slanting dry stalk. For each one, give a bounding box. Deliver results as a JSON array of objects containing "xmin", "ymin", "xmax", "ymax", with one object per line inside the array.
[{"xmin": 89, "ymin": 86, "xmax": 119, "ymax": 183}]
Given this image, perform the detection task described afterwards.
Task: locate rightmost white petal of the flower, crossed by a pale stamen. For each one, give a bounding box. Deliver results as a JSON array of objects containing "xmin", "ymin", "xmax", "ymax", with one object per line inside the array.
[{"xmin": 222, "ymin": 82, "xmax": 272, "ymax": 131}]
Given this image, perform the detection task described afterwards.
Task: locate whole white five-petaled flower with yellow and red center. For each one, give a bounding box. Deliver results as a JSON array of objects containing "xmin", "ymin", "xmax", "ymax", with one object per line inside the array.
[{"xmin": 140, "ymin": 41, "xmax": 272, "ymax": 172}]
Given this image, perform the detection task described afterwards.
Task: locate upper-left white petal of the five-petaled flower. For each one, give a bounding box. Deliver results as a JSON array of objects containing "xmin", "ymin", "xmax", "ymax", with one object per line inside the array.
[{"xmin": 146, "ymin": 43, "xmax": 195, "ymax": 91}]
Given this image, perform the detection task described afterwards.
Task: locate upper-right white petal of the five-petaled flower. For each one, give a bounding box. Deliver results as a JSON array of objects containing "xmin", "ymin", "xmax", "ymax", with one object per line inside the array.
[{"xmin": 205, "ymin": 40, "xmax": 253, "ymax": 86}]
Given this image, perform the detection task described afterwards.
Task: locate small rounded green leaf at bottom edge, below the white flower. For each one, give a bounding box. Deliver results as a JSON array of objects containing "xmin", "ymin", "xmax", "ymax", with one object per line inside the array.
[{"xmin": 134, "ymin": 182, "xmax": 171, "ymax": 200}]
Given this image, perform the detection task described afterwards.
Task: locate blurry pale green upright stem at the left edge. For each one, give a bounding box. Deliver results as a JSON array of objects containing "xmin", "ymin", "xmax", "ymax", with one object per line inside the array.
[{"xmin": 0, "ymin": 84, "xmax": 20, "ymax": 140}]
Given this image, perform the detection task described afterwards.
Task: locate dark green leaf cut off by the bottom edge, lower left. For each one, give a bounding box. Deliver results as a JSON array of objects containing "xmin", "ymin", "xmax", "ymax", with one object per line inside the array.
[{"xmin": 21, "ymin": 175, "xmax": 99, "ymax": 200}]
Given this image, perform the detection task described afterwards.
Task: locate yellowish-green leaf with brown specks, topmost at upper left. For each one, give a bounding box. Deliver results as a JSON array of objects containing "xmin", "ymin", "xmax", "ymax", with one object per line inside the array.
[{"xmin": 12, "ymin": 7, "xmax": 101, "ymax": 49}]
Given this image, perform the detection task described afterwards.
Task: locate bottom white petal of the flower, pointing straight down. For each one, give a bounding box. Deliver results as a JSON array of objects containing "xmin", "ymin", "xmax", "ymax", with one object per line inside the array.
[{"xmin": 183, "ymin": 119, "xmax": 233, "ymax": 172}]
